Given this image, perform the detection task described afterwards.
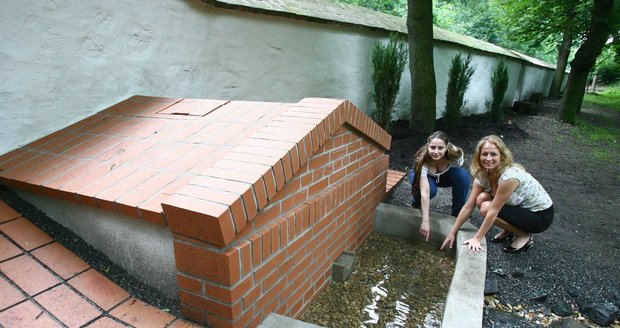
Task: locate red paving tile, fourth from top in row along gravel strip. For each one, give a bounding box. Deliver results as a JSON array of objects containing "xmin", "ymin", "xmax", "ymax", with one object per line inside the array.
[{"xmin": 69, "ymin": 269, "xmax": 129, "ymax": 311}]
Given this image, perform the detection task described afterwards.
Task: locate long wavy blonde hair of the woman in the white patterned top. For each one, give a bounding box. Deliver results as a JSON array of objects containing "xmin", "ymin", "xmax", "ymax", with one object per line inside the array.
[{"xmin": 469, "ymin": 135, "xmax": 523, "ymax": 189}]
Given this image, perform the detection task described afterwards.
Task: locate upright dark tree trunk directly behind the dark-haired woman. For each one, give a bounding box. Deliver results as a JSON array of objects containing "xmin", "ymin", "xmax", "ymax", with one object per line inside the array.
[{"xmin": 407, "ymin": 0, "xmax": 437, "ymax": 133}]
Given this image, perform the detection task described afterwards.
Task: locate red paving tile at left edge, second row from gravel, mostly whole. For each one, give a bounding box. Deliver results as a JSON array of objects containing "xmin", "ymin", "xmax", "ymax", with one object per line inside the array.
[{"xmin": 0, "ymin": 255, "xmax": 60, "ymax": 296}]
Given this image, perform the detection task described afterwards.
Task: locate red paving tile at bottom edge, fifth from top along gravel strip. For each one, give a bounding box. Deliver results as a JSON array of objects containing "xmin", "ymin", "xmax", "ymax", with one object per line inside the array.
[{"xmin": 110, "ymin": 298, "xmax": 174, "ymax": 328}]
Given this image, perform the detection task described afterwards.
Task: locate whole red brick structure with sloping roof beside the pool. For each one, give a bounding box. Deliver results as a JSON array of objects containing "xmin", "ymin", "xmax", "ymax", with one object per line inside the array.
[{"xmin": 0, "ymin": 96, "xmax": 391, "ymax": 327}]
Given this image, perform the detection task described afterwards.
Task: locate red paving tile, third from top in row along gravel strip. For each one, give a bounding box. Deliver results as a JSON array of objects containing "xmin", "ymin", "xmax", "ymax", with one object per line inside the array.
[{"xmin": 31, "ymin": 243, "xmax": 90, "ymax": 280}]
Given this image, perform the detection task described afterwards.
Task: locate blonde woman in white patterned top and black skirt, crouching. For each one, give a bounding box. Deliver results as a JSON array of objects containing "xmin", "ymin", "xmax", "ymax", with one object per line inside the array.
[{"xmin": 441, "ymin": 135, "xmax": 554, "ymax": 253}]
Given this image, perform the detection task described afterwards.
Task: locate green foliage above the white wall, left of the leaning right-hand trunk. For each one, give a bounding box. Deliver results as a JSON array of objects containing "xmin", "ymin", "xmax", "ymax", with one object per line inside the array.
[{"xmin": 331, "ymin": 0, "xmax": 592, "ymax": 63}]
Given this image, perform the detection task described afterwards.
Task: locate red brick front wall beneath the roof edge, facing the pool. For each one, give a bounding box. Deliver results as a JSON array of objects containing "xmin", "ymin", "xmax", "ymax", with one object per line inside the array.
[{"xmin": 175, "ymin": 125, "xmax": 388, "ymax": 327}]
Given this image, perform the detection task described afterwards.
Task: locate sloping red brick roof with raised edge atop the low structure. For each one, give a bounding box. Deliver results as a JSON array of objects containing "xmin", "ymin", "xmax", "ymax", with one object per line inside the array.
[{"xmin": 0, "ymin": 96, "xmax": 391, "ymax": 246}]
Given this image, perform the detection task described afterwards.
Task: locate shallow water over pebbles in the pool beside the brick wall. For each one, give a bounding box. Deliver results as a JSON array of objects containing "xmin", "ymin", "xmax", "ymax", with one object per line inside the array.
[{"xmin": 300, "ymin": 233, "xmax": 454, "ymax": 327}]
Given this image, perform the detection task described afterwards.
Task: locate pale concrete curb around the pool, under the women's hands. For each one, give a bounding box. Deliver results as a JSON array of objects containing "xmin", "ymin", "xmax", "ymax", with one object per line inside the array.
[{"xmin": 375, "ymin": 203, "xmax": 487, "ymax": 328}]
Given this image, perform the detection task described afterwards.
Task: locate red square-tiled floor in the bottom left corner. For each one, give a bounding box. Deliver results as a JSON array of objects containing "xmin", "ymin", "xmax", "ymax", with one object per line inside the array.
[{"xmin": 0, "ymin": 201, "xmax": 197, "ymax": 328}]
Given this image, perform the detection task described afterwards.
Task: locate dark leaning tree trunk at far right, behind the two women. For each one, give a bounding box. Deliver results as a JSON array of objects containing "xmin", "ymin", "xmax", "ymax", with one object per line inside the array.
[{"xmin": 558, "ymin": 0, "xmax": 619, "ymax": 124}]
